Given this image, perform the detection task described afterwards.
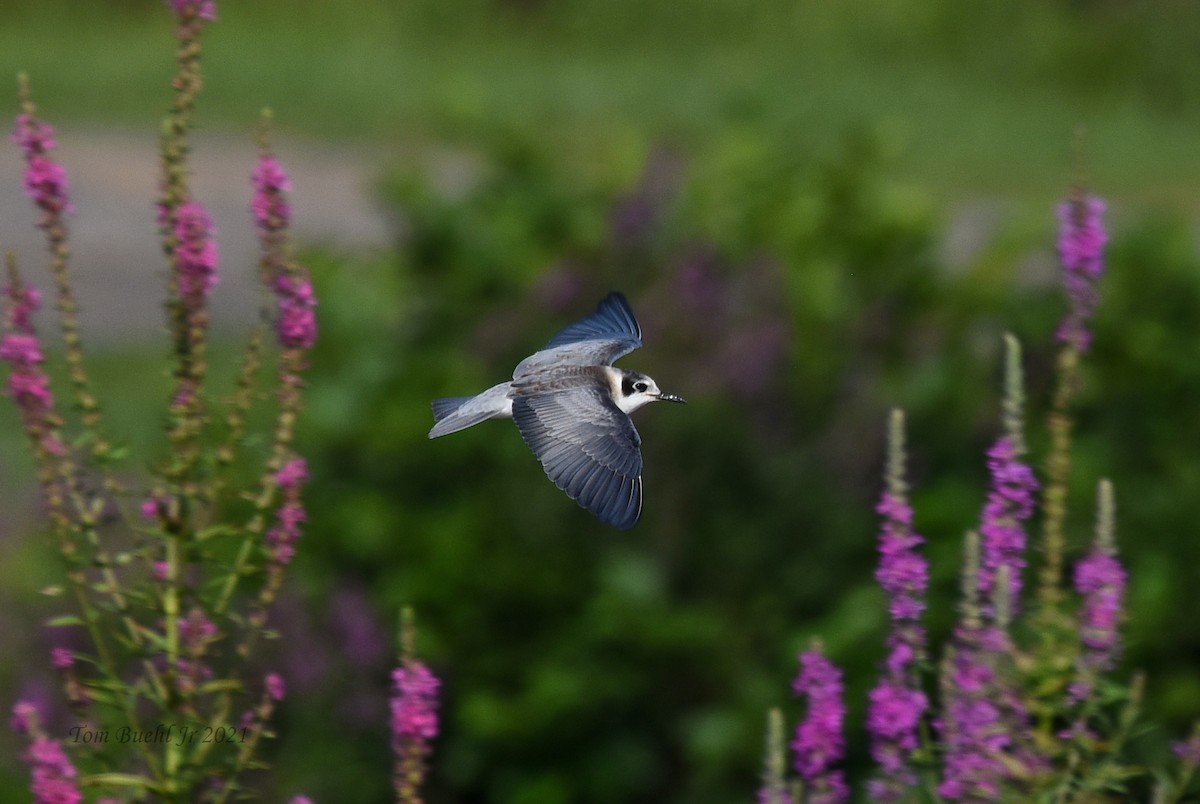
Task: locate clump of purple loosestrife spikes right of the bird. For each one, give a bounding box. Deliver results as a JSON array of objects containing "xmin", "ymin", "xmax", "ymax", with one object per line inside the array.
[{"xmin": 758, "ymin": 191, "xmax": 1200, "ymax": 804}]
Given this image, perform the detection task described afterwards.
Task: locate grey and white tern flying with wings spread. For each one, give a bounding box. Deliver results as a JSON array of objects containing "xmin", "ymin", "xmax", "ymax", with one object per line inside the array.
[{"xmin": 430, "ymin": 292, "xmax": 684, "ymax": 530}]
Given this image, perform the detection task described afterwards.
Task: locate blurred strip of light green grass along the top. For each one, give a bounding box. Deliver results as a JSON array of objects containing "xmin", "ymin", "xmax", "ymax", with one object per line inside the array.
[{"xmin": 7, "ymin": 0, "xmax": 1200, "ymax": 205}]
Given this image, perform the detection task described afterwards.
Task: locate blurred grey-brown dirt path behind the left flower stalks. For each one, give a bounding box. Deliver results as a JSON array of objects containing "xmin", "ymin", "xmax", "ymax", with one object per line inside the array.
[{"xmin": 0, "ymin": 126, "xmax": 391, "ymax": 346}]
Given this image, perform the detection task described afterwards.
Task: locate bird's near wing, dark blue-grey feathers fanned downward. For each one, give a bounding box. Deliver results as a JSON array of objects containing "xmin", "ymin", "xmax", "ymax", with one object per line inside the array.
[{"xmin": 512, "ymin": 378, "xmax": 642, "ymax": 530}]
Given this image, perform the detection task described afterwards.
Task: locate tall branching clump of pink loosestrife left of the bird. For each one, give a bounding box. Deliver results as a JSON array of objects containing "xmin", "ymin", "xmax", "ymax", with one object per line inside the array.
[{"xmin": 0, "ymin": 0, "xmax": 317, "ymax": 802}]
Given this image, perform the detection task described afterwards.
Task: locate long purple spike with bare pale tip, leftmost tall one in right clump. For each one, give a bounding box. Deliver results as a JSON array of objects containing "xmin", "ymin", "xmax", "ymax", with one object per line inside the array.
[{"xmin": 866, "ymin": 410, "xmax": 929, "ymax": 802}]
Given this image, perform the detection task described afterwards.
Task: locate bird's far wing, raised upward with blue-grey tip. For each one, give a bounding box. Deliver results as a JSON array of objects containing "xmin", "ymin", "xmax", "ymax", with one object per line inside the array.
[{"xmin": 512, "ymin": 292, "xmax": 642, "ymax": 379}]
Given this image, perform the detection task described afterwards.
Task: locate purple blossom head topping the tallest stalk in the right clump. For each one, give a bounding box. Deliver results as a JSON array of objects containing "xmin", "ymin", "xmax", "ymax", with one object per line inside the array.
[{"xmin": 1058, "ymin": 192, "xmax": 1109, "ymax": 352}]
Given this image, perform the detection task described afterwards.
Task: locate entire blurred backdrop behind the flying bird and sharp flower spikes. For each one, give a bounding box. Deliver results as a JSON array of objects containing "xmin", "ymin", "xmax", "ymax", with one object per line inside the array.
[{"xmin": 0, "ymin": 0, "xmax": 1200, "ymax": 804}]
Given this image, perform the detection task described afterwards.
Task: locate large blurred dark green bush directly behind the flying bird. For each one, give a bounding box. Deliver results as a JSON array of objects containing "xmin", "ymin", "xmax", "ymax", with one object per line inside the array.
[{"xmin": 276, "ymin": 123, "xmax": 1200, "ymax": 803}]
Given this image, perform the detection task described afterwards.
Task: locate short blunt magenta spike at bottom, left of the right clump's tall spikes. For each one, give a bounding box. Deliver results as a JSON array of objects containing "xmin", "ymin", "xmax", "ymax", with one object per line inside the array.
[{"xmin": 792, "ymin": 646, "xmax": 850, "ymax": 804}]
